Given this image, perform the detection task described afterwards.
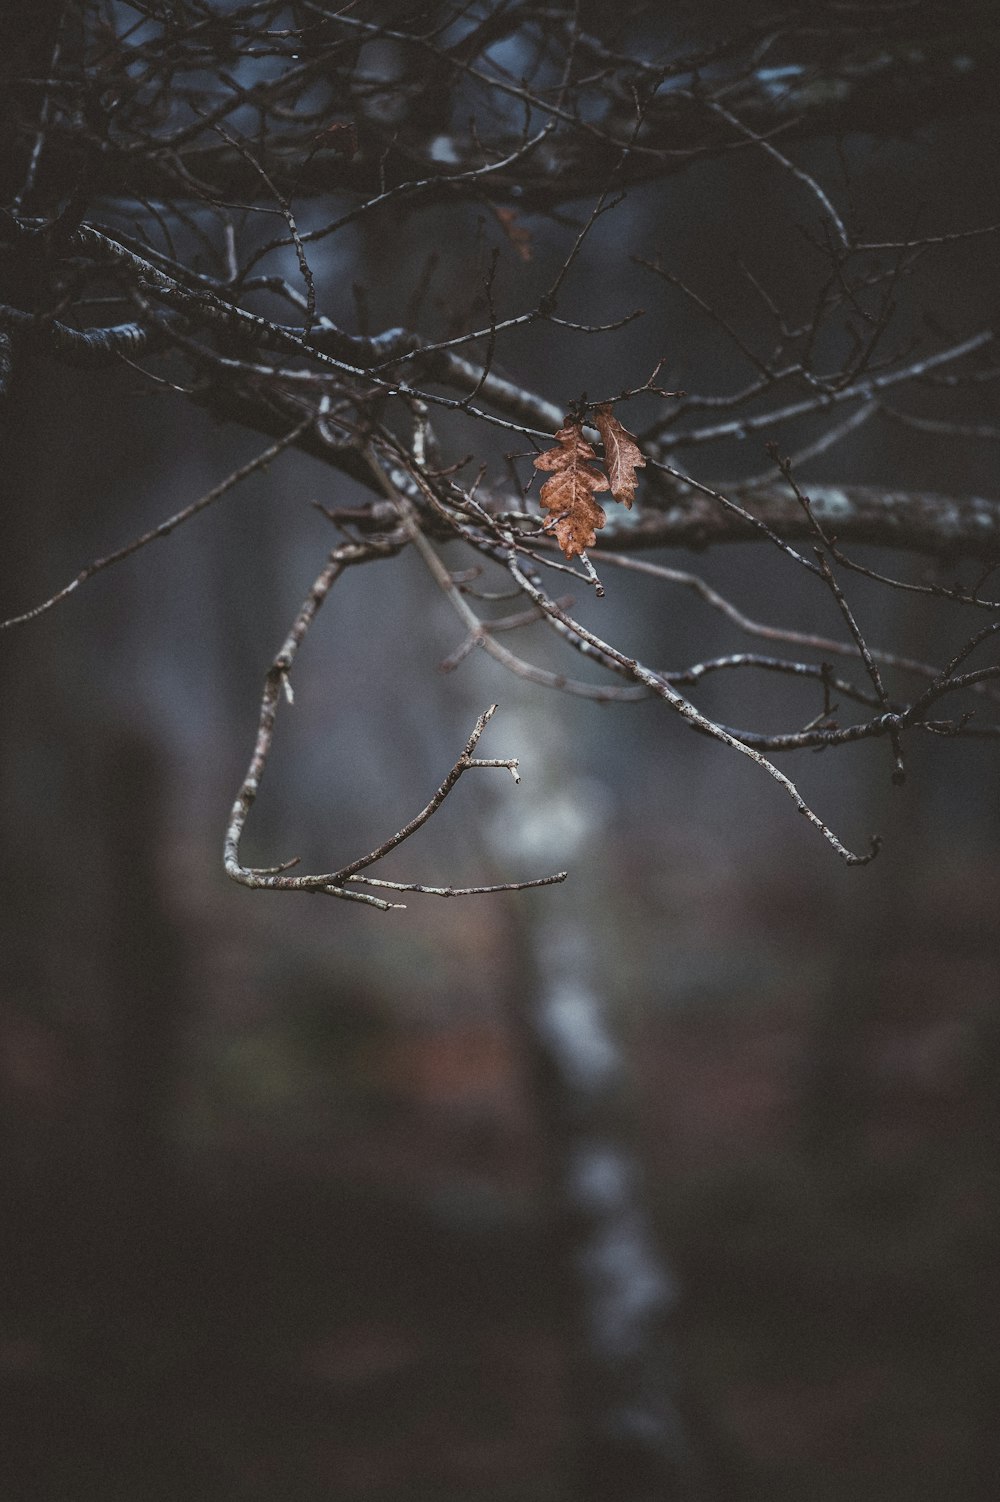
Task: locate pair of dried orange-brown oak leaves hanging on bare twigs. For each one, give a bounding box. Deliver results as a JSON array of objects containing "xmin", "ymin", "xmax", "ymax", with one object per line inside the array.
[{"xmin": 535, "ymin": 401, "xmax": 646, "ymax": 559}]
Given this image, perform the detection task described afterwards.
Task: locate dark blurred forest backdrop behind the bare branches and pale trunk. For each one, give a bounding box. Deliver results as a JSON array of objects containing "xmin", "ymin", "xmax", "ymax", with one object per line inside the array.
[{"xmin": 0, "ymin": 6, "xmax": 1000, "ymax": 1502}]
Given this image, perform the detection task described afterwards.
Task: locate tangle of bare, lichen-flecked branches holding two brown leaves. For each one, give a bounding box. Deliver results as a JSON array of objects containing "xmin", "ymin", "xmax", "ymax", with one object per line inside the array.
[{"xmin": 0, "ymin": 0, "xmax": 1000, "ymax": 889}]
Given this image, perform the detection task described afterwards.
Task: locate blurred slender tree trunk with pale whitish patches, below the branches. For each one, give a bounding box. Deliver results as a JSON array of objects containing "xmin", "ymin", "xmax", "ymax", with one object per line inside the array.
[{"xmin": 492, "ymin": 729, "xmax": 721, "ymax": 1502}]
